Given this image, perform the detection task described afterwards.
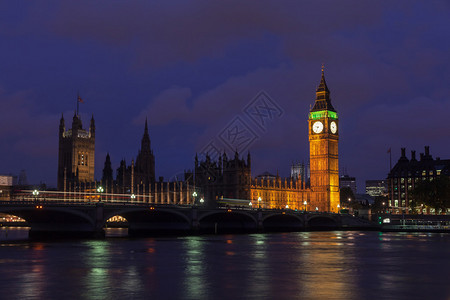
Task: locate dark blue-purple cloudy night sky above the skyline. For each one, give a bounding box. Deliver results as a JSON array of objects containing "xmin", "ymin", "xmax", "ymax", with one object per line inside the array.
[{"xmin": 0, "ymin": 0, "xmax": 450, "ymax": 192}]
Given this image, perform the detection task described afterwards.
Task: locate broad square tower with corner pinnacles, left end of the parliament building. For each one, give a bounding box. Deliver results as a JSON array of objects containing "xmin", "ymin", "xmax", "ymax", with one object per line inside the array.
[{"xmin": 58, "ymin": 113, "xmax": 95, "ymax": 190}]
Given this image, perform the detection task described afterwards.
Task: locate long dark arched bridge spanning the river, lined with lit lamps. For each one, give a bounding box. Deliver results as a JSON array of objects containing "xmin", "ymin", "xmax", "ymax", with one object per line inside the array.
[{"xmin": 0, "ymin": 201, "xmax": 372, "ymax": 237}]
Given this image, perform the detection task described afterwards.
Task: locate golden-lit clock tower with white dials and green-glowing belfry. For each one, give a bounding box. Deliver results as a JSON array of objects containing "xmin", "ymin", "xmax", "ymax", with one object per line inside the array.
[{"xmin": 308, "ymin": 67, "xmax": 340, "ymax": 212}]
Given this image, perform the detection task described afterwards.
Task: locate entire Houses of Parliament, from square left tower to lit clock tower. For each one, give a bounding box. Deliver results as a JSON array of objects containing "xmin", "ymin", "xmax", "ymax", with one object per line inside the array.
[{"xmin": 58, "ymin": 68, "xmax": 339, "ymax": 212}]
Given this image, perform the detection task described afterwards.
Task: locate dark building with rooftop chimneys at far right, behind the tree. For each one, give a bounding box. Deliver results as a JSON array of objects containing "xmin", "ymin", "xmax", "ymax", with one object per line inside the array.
[{"xmin": 387, "ymin": 146, "xmax": 450, "ymax": 213}]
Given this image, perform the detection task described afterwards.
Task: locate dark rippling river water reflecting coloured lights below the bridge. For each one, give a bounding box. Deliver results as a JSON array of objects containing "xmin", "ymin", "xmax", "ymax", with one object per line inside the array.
[{"xmin": 0, "ymin": 228, "xmax": 450, "ymax": 299}]
